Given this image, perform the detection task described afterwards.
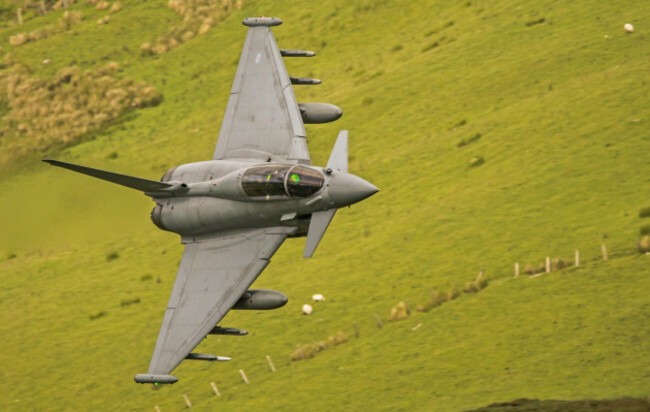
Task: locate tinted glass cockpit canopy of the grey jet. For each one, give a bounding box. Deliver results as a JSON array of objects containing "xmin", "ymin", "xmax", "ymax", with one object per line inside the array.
[{"xmin": 241, "ymin": 164, "xmax": 325, "ymax": 199}]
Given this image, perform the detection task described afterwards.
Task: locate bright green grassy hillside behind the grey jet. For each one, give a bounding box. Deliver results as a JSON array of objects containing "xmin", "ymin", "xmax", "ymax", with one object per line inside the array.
[{"xmin": 0, "ymin": 0, "xmax": 650, "ymax": 411}]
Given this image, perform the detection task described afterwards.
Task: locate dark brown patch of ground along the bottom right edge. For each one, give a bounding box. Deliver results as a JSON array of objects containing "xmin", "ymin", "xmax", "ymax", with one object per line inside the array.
[{"xmin": 468, "ymin": 398, "xmax": 650, "ymax": 412}]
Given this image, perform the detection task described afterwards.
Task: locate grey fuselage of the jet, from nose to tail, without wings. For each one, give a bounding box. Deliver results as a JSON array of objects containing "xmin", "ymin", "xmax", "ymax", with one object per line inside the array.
[{"xmin": 151, "ymin": 160, "xmax": 377, "ymax": 238}]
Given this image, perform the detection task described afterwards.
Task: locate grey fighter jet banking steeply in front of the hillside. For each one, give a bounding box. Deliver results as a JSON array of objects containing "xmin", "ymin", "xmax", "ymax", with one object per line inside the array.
[{"xmin": 44, "ymin": 17, "xmax": 378, "ymax": 385}]
